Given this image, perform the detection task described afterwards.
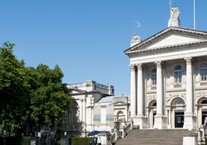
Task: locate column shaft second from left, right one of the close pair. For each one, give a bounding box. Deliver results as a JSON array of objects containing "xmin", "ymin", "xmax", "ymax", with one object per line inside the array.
[{"xmin": 137, "ymin": 64, "xmax": 143, "ymax": 116}]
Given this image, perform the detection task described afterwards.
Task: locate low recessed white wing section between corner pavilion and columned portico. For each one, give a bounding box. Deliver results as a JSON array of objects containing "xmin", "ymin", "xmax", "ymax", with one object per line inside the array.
[{"xmin": 94, "ymin": 96, "xmax": 130, "ymax": 132}]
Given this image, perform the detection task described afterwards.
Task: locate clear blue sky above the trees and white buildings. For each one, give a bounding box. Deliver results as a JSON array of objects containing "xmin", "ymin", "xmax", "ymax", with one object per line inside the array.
[{"xmin": 0, "ymin": 0, "xmax": 207, "ymax": 96}]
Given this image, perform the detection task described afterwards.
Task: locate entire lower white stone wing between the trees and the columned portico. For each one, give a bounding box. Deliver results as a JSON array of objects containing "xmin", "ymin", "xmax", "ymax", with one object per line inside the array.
[{"xmin": 63, "ymin": 81, "xmax": 130, "ymax": 136}]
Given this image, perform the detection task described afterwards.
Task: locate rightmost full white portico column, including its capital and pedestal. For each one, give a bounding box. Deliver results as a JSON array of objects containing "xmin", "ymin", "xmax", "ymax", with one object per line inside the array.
[{"xmin": 184, "ymin": 57, "xmax": 195, "ymax": 129}]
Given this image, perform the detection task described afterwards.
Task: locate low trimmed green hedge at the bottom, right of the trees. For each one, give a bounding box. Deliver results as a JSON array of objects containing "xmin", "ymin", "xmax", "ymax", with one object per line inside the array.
[{"xmin": 71, "ymin": 137, "xmax": 94, "ymax": 145}]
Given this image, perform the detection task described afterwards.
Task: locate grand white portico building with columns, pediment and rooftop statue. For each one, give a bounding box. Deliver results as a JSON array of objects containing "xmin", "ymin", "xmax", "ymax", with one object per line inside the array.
[{"xmin": 124, "ymin": 7, "xmax": 207, "ymax": 129}]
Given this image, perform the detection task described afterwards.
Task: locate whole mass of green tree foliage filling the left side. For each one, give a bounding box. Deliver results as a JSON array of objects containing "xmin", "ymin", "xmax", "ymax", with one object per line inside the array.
[{"xmin": 0, "ymin": 42, "xmax": 70, "ymax": 133}]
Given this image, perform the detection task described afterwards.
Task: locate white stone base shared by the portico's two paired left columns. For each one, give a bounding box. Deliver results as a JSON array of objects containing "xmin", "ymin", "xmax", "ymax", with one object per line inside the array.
[{"xmin": 131, "ymin": 115, "xmax": 148, "ymax": 129}]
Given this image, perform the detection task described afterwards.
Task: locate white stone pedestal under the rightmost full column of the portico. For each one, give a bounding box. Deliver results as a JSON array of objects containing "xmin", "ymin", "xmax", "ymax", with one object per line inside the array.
[{"xmin": 183, "ymin": 113, "xmax": 197, "ymax": 130}]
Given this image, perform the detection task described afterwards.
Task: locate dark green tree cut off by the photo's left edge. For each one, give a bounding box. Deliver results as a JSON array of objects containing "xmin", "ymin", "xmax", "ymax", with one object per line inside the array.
[{"xmin": 0, "ymin": 42, "xmax": 29, "ymax": 132}]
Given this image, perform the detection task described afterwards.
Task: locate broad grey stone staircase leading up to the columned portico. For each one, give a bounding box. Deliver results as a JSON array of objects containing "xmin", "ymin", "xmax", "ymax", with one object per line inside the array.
[{"xmin": 116, "ymin": 129, "xmax": 194, "ymax": 145}]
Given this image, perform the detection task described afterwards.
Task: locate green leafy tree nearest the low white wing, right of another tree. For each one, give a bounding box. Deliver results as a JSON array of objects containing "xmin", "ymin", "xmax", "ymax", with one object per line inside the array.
[{"xmin": 31, "ymin": 64, "xmax": 70, "ymax": 127}]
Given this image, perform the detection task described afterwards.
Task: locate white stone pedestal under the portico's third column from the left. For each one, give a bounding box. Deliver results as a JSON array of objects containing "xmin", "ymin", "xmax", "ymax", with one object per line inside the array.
[{"xmin": 154, "ymin": 114, "xmax": 167, "ymax": 129}]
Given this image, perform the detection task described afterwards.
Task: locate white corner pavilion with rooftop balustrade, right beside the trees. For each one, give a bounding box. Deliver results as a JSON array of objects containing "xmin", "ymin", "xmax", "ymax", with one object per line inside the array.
[{"xmin": 66, "ymin": 81, "xmax": 114, "ymax": 136}]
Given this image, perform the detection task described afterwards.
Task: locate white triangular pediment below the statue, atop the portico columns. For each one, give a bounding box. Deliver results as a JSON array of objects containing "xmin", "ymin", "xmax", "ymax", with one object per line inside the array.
[{"xmin": 125, "ymin": 27, "xmax": 207, "ymax": 54}]
